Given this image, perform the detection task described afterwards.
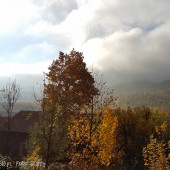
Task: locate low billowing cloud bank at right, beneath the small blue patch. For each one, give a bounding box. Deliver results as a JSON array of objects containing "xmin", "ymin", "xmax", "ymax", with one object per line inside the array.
[{"xmin": 93, "ymin": 26, "xmax": 170, "ymax": 82}]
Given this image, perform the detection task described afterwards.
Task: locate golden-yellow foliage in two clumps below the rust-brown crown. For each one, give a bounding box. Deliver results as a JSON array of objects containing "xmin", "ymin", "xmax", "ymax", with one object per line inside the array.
[{"xmin": 69, "ymin": 108, "xmax": 120, "ymax": 170}]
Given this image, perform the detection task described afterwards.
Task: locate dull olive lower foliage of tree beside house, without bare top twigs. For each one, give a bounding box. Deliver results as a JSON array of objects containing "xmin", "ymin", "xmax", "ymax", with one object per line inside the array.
[{"xmin": 27, "ymin": 106, "xmax": 61, "ymax": 168}]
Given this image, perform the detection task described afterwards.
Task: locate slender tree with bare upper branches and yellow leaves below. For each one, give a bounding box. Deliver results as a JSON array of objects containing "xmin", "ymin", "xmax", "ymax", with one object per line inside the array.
[{"xmin": 66, "ymin": 69, "xmax": 117, "ymax": 168}]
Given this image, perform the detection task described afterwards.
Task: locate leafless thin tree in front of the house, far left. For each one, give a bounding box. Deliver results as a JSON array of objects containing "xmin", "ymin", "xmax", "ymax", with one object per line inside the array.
[{"xmin": 1, "ymin": 80, "xmax": 21, "ymax": 155}]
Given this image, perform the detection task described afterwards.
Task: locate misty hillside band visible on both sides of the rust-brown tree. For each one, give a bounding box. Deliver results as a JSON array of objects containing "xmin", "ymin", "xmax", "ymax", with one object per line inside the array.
[{"xmin": 0, "ymin": 74, "xmax": 170, "ymax": 115}]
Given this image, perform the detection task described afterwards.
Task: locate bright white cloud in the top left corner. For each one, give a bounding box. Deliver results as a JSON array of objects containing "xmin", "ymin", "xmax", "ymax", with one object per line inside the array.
[{"xmin": 0, "ymin": 0, "xmax": 38, "ymax": 34}]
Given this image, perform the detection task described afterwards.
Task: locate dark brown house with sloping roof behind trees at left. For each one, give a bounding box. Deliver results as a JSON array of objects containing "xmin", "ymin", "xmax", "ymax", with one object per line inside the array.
[{"xmin": 0, "ymin": 110, "xmax": 40, "ymax": 160}]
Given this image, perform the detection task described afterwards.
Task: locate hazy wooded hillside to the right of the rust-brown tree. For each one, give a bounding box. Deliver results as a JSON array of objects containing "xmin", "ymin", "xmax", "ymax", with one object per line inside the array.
[{"xmin": 114, "ymin": 80, "xmax": 170, "ymax": 112}]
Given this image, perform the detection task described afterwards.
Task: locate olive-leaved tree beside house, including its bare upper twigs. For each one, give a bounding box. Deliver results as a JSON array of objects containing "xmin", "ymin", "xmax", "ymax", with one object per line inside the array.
[{"xmin": 30, "ymin": 73, "xmax": 61, "ymax": 168}]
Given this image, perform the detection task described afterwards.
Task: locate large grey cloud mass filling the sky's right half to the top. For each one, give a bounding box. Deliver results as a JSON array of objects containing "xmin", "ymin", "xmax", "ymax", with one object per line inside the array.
[{"xmin": 80, "ymin": 0, "xmax": 170, "ymax": 83}]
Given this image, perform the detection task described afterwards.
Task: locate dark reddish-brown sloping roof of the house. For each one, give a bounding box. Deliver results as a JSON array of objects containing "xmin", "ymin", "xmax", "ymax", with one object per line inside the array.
[{"xmin": 0, "ymin": 110, "xmax": 40, "ymax": 132}]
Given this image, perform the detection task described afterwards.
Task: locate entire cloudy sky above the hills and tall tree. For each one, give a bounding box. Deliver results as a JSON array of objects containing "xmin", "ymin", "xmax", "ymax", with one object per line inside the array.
[{"xmin": 0, "ymin": 0, "xmax": 170, "ymax": 83}]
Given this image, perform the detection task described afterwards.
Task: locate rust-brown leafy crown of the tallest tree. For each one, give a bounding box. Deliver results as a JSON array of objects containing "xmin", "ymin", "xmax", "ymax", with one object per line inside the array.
[{"xmin": 45, "ymin": 49, "xmax": 98, "ymax": 114}]
